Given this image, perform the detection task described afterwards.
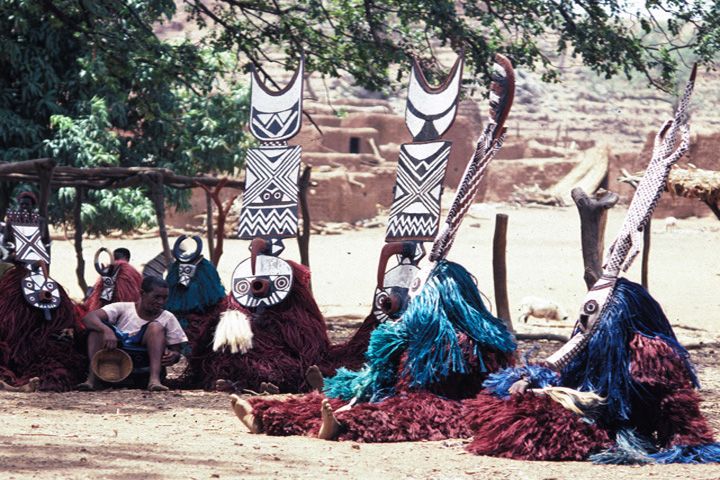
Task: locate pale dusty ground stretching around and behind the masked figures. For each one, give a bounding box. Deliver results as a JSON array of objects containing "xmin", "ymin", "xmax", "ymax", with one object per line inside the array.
[{"xmin": 0, "ymin": 205, "xmax": 720, "ymax": 479}]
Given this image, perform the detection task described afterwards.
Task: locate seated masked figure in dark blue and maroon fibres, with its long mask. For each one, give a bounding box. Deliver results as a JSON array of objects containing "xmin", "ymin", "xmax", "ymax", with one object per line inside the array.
[{"xmin": 468, "ymin": 64, "xmax": 720, "ymax": 463}]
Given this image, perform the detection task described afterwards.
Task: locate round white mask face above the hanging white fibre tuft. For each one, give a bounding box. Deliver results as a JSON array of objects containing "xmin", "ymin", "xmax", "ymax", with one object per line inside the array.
[{"xmin": 232, "ymin": 255, "xmax": 292, "ymax": 308}]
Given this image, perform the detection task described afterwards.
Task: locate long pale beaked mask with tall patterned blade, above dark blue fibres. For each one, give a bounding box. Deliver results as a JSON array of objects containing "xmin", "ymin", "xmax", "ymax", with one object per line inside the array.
[{"xmin": 546, "ymin": 66, "xmax": 697, "ymax": 370}]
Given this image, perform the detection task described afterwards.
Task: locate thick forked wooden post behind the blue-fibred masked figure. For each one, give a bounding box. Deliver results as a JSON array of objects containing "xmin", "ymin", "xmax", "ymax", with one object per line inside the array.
[{"xmin": 570, "ymin": 187, "xmax": 619, "ymax": 289}]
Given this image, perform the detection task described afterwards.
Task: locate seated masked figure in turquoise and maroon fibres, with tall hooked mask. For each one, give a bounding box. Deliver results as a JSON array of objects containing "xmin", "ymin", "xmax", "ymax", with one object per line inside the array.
[{"xmin": 232, "ymin": 56, "xmax": 515, "ymax": 442}]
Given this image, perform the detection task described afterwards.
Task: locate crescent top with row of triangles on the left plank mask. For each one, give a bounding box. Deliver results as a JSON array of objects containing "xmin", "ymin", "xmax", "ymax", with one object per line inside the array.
[{"xmin": 250, "ymin": 58, "xmax": 305, "ymax": 142}]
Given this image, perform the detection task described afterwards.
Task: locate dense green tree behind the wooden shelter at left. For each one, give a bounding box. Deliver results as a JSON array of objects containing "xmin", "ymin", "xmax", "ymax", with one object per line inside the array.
[{"xmin": 0, "ymin": 0, "xmax": 248, "ymax": 232}]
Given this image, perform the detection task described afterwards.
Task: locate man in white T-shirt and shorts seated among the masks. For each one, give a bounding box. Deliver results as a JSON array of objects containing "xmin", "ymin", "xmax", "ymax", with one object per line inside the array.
[{"xmin": 78, "ymin": 277, "xmax": 187, "ymax": 392}]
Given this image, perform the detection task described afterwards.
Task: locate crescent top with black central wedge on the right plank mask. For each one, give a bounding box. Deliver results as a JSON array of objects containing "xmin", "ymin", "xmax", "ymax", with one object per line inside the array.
[{"xmin": 405, "ymin": 54, "xmax": 464, "ymax": 142}]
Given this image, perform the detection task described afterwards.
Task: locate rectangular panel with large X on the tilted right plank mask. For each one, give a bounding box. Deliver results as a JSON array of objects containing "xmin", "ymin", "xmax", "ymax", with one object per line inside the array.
[{"xmin": 385, "ymin": 142, "xmax": 452, "ymax": 241}]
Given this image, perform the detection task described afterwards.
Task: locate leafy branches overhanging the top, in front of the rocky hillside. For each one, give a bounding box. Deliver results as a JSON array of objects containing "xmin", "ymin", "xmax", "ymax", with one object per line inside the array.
[{"xmin": 186, "ymin": 0, "xmax": 720, "ymax": 90}]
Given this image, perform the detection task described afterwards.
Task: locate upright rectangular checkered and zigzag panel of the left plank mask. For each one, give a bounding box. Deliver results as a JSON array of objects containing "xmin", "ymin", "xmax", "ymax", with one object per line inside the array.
[{"xmin": 238, "ymin": 146, "xmax": 302, "ymax": 240}]
